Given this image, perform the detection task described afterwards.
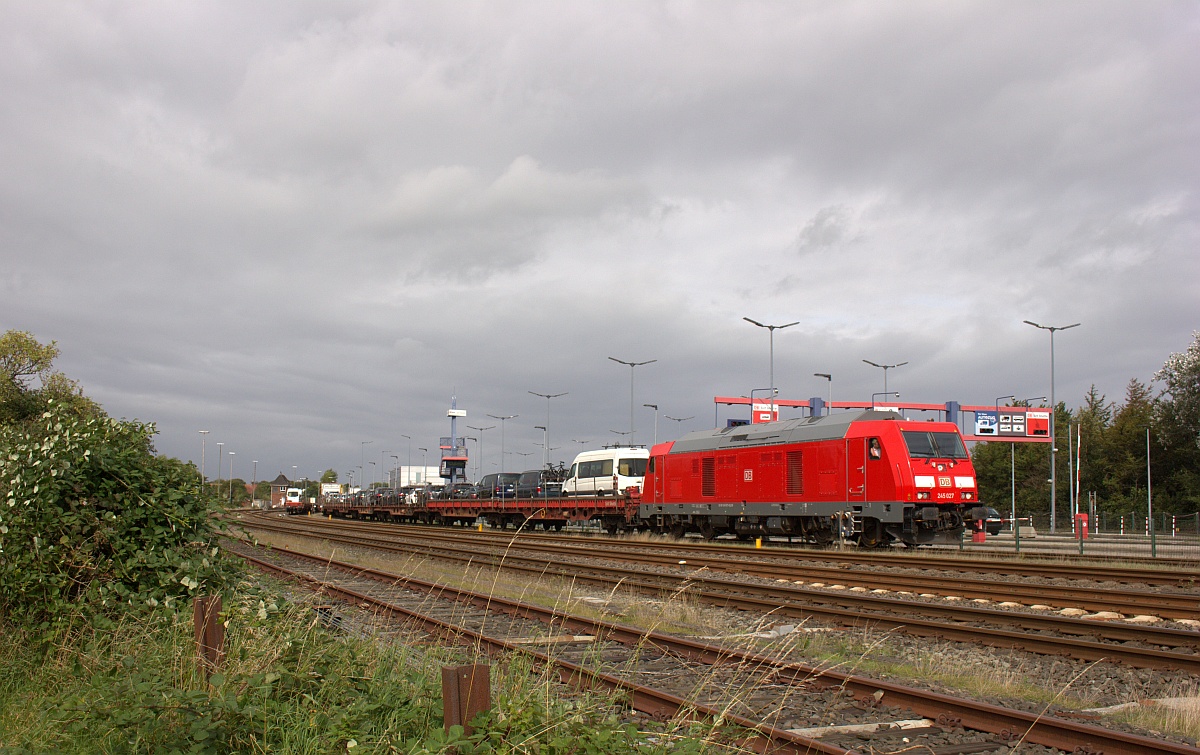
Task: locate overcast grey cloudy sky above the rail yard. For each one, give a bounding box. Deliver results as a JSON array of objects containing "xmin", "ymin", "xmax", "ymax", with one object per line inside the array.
[{"xmin": 0, "ymin": 0, "xmax": 1200, "ymax": 481}]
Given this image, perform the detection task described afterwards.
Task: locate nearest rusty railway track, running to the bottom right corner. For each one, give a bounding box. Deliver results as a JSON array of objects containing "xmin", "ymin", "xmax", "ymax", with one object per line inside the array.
[{"xmin": 226, "ymin": 535, "xmax": 1200, "ymax": 755}]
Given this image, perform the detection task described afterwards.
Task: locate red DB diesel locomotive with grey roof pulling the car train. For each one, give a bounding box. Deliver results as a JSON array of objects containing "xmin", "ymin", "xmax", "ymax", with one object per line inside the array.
[{"xmin": 637, "ymin": 411, "xmax": 985, "ymax": 547}]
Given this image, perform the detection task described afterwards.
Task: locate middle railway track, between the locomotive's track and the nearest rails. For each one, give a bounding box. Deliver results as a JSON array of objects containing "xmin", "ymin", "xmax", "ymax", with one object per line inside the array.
[{"xmin": 234, "ymin": 511, "xmax": 1200, "ymax": 676}]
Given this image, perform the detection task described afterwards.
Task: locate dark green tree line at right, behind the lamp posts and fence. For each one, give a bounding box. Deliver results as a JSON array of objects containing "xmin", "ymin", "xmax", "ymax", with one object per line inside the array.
[{"xmin": 972, "ymin": 331, "xmax": 1200, "ymax": 523}]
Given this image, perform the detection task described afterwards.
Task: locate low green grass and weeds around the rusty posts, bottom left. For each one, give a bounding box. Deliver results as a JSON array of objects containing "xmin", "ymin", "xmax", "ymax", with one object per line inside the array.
[{"xmin": 0, "ymin": 583, "xmax": 720, "ymax": 755}]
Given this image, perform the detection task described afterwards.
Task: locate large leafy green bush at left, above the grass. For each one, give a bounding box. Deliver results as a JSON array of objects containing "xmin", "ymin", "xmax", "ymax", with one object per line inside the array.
[{"xmin": 0, "ymin": 400, "xmax": 235, "ymax": 642}]
